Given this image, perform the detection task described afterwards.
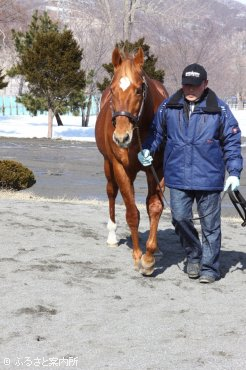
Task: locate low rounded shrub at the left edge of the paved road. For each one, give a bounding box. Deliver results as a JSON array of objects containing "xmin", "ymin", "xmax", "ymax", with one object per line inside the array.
[{"xmin": 0, "ymin": 160, "xmax": 36, "ymax": 190}]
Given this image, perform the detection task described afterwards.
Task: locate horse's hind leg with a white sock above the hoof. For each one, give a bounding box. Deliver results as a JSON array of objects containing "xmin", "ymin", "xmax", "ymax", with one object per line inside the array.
[{"xmin": 104, "ymin": 159, "xmax": 119, "ymax": 247}]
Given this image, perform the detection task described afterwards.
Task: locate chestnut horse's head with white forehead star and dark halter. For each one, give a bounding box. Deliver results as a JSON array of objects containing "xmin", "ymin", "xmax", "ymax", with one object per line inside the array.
[{"xmin": 110, "ymin": 48, "xmax": 147, "ymax": 148}]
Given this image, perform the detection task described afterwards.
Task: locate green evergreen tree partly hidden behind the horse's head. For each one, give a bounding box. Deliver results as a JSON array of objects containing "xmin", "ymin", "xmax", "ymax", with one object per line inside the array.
[{"xmin": 97, "ymin": 37, "xmax": 165, "ymax": 92}]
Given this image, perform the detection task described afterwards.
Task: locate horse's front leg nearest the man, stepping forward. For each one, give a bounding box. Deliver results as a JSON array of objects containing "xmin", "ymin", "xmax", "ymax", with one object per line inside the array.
[{"xmin": 141, "ymin": 169, "xmax": 164, "ymax": 275}]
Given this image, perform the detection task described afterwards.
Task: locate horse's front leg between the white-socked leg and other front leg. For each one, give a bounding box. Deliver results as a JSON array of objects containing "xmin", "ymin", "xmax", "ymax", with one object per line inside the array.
[{"xmin": 114, "ymin": 163, "xmax": 142, "ymax": 270}]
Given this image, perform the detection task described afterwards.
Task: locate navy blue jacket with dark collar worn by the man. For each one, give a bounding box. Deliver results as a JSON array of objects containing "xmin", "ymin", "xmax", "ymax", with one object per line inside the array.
[{"xmin": 143, "ymin": 89, "xmax": 243, "ymax": 191}]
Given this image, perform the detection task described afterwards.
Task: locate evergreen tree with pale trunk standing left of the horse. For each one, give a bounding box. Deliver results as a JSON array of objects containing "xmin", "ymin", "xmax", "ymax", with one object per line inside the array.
[{"xmin": 9, "ymin": 12, "xmax": 85, "ymax": 137}]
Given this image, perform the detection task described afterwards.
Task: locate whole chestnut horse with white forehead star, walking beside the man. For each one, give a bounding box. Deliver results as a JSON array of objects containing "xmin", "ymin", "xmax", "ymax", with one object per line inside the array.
[{"xmin": 96, "ymin": 48, "xmax": 168, "ymax": 275}]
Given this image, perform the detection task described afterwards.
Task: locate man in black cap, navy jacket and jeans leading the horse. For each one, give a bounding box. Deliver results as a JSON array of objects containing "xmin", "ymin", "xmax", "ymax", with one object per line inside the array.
[{"xmin": 138, "ymin": 63, "xmax": 243, "ymax": 283}]
